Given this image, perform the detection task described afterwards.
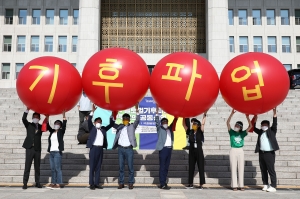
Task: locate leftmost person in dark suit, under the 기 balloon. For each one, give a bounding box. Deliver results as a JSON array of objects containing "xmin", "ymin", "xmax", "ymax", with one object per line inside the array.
[{"xmin": 22, "ymin": 108, "xmax": 42, "ymax": 189}]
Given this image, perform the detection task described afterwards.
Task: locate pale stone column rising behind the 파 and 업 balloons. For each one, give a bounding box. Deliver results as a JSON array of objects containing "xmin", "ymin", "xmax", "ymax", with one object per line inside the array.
[{"xmin": 206, "ymin": 0, "xmax": 229, "ymax": 74}]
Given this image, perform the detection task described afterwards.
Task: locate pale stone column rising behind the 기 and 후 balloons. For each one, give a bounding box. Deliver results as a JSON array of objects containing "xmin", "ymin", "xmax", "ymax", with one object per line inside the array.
[{"xmin": 77, "ymin": 0, "xmax": 101, "ymax": 73}]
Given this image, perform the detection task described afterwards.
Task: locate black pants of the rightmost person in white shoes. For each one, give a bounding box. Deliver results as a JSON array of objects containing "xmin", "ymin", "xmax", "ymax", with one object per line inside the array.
[{"xmin": 259, "ymin": 151, "xmax": 277, "ymax": 188}]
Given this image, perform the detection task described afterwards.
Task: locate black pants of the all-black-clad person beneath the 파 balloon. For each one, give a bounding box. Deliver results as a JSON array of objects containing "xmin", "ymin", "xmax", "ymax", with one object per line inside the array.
[{"xmin": 189, "ymin": 147, "xmax": 205, "ymax": 185}]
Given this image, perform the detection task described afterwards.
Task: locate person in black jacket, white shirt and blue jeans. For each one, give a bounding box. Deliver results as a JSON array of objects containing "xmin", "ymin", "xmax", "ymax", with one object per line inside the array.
[{"xmin": 46, "ymin": 112, "xmax": 67, "ymax": 189}]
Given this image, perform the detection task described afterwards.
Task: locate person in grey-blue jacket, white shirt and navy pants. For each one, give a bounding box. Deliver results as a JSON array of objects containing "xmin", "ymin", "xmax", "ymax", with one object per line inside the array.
[{"xmin": 155, "ymin": 105, "xmax": 178, "ymax": 190}]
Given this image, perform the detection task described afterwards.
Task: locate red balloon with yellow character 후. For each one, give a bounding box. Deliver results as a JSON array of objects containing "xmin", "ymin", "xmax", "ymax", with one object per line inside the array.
[{"xmin": 82, "ymin": 48, "xmax": 150, "ymax": 111}]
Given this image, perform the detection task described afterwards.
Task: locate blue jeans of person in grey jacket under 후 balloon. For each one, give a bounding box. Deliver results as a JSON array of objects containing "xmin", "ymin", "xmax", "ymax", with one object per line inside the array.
[{"xmin": 118, "ymin": 147, "xmax": 135, "ymax": 184}]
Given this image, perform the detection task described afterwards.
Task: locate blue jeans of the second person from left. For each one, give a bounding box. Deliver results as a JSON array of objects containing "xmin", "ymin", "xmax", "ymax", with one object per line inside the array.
[{"xmin": 49, "ymin": 151, "xmax": 62, "ymax": 184}]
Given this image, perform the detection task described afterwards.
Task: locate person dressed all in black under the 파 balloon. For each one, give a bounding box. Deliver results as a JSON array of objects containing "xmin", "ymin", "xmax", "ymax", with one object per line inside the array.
[{"xmin": 183, "ymin": 112, "xmax": 206, "ymax": 190}]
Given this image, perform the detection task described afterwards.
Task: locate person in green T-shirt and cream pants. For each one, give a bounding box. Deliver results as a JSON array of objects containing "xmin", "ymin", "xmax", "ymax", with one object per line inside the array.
[{"xmin": 227, "ymin": 109, "xmax": 252, "ymax": 191}]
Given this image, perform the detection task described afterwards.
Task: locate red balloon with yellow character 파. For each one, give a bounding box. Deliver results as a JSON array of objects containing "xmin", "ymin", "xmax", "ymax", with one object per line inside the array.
[{"xmin": 150, "ymin": 52, "xmax": 219, "ymax": 117}]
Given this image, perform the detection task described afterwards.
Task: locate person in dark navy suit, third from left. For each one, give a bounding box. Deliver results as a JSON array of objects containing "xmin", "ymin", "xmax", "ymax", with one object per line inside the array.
[{"xmin": 86, "ymin": 105, "xmax": 115, "ymax": 190}]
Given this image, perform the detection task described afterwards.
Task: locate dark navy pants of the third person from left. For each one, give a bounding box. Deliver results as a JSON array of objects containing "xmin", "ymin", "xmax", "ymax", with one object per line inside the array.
[{"xmin": 89, "ymin": 146, "xmax": 103, "ymax": 185}]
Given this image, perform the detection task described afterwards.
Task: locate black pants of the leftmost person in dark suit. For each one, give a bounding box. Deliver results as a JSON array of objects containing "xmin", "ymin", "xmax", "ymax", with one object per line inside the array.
[{"xmin": 23, "ymin": 147, "xmax": 41, "ymax": 184}]
